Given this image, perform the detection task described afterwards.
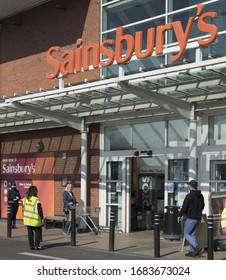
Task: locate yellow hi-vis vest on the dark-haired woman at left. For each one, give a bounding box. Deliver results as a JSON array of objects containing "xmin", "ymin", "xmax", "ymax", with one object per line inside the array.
[{"xmin": 22, "ymin": 196, "xmax": 42, "ymax": 227}]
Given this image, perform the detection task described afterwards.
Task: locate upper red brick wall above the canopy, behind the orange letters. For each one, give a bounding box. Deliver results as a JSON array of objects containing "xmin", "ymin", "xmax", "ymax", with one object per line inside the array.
[{"xmin": 0, "ymin": 0, "xmax": 100, "ymax": 98}]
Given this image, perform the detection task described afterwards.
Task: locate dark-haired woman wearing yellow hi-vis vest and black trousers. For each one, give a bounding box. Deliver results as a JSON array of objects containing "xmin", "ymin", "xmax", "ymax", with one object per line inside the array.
[{"xmin": 22, "ymin": 186, "xmax": 43, "ymax": 250}]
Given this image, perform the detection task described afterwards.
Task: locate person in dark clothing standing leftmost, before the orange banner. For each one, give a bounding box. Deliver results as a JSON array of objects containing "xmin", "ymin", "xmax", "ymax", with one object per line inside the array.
[{"xmin": 7, "ymin": 183, "xmax": 21, "ymax": 228}]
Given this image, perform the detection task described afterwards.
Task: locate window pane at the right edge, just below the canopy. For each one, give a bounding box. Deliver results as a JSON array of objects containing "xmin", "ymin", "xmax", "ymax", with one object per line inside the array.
[{"xmin": 209, "ymin": 115, "xmax": 226, "ymax": 145}]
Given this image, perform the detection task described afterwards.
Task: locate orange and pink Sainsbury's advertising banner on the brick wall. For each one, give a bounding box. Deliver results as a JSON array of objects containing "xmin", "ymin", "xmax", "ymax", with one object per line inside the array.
[{"xmin": 1, "ymin": 154, "xmax": 54, "ymax": 219}]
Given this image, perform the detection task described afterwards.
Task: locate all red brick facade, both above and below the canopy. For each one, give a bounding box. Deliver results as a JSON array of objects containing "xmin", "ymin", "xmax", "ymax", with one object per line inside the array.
[{"xmin": 0, "ymin": 0, "xmax": 100, "ymax": 215}]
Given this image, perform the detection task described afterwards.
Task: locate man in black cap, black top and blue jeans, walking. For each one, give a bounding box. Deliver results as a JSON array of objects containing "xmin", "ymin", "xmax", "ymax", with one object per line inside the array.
[{"xmin": 178, "ymin": 180, "xmax": 205, "ymax": 257}]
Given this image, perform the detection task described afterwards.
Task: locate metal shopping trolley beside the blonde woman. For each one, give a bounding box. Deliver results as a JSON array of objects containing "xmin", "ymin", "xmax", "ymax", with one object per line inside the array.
[{"xmin": 76, "ymin": 206, "xmax": 99, "ymax": 234}]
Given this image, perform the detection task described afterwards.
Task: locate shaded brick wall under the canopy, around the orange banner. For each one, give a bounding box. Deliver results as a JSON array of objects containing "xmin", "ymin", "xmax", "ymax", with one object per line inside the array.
[{"xmin": 0, "ymin": 125, "xmax": 99, "ymax": 215}]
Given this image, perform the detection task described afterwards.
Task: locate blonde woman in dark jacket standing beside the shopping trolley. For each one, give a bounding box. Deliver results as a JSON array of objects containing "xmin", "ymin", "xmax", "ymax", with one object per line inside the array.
[{"xmin": 62, "ymin": 183, "xmax": 77, "ymax": 234}]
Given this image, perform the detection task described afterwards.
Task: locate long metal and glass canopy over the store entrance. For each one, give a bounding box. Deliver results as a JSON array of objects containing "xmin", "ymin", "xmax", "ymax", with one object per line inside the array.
[{"xmin": 0, "ymin": 57, "xmax": 226, "ymax": 133}]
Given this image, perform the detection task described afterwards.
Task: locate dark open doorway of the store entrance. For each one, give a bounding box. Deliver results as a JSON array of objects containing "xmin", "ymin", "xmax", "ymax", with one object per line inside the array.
[{"xmin": 131, "ymin": 158, "xmax": 165, "ymax": 231}]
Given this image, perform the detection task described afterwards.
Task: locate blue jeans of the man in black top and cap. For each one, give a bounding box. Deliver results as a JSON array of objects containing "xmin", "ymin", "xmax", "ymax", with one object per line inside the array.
[{"xmin": 184, "ymin": 219, "xmax": 200, "ymax": 252}]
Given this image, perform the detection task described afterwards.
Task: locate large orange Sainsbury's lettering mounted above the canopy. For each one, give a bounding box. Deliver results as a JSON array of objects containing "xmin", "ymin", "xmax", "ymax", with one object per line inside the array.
[{"xmin": 46, "ymin": 4, "xmax": 218, "ymax": 79}]
